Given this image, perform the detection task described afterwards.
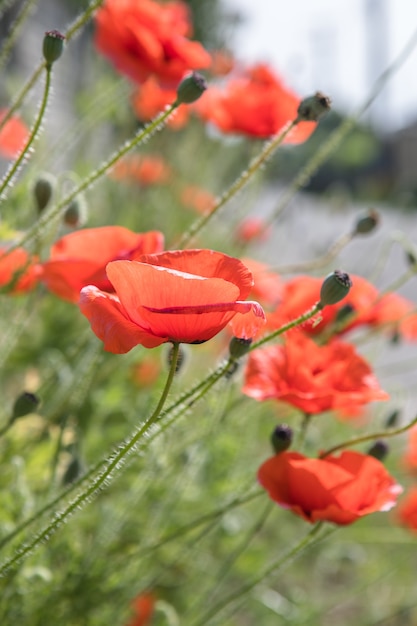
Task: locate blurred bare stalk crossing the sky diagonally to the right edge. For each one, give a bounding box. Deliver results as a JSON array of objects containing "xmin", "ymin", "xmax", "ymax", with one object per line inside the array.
[{"xmin": 266, "ymin": 24, "xmax": 417, "ymax": 226}]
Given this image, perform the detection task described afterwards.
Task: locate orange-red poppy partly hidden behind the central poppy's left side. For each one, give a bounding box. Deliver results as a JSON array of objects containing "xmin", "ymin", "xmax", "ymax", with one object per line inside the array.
[{"xmin": 42, "ymin": 226, "xmax": 164, "ymax": 302}]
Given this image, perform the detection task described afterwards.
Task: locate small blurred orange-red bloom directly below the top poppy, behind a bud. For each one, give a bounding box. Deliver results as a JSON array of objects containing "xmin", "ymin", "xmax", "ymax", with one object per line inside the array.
[{"xmin": 132, "ymin": 76, "xmax": 189, "ymax": 129}]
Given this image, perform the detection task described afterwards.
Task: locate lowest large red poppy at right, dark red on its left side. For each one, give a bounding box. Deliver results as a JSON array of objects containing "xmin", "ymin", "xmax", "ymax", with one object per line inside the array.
[{"xmin": 258, "ymin": 450, "xmax": 402, "ymax": 525}]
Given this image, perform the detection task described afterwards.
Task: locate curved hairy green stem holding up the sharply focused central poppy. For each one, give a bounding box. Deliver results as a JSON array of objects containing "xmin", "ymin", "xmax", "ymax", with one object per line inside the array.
[{"xmin": 0, "ymin": 343, "xmax": 179, "ymax": 576}]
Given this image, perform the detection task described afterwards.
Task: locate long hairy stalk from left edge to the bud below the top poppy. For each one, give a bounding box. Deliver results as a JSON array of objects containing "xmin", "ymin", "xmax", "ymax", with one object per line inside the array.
[{"xmin": 0, "ymin": 102, "xmax": 178, "ymax": 259}]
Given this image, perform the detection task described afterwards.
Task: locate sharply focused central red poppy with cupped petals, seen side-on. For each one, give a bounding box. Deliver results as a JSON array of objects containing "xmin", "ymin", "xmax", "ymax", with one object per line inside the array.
[{"xmin": 80, "ymin": 250, "xmax": 264, "ymax": 353}]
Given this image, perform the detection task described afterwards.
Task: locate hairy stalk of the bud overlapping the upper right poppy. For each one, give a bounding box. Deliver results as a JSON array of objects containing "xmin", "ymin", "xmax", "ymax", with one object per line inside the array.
[{"xmin": 173, "ymin": 117, "xmax": 299, "ymax": 249}]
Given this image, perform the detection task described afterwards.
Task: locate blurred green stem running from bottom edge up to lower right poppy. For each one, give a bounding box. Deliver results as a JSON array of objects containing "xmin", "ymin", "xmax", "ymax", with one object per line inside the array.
[{"xmin": 191, "ymin": 522, "xmax": 330, "ymax": 626}]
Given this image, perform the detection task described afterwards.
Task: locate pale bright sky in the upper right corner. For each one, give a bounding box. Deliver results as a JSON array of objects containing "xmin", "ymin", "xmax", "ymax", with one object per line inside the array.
[{"xmin": 223, "ymin": 0, "xmax": 417, "ymax": 128}]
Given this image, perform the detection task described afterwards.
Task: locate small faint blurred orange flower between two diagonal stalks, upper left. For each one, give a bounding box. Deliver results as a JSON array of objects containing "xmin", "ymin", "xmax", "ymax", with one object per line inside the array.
[{"xmin": 110, "ymin": 154, "xmax": 172, "ymax": 186}]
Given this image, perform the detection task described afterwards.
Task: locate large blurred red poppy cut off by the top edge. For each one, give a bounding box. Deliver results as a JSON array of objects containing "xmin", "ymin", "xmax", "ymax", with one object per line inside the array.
[{"xmin": 95, "ymin": 0, "xmax": 211, "ymax": 87}]
